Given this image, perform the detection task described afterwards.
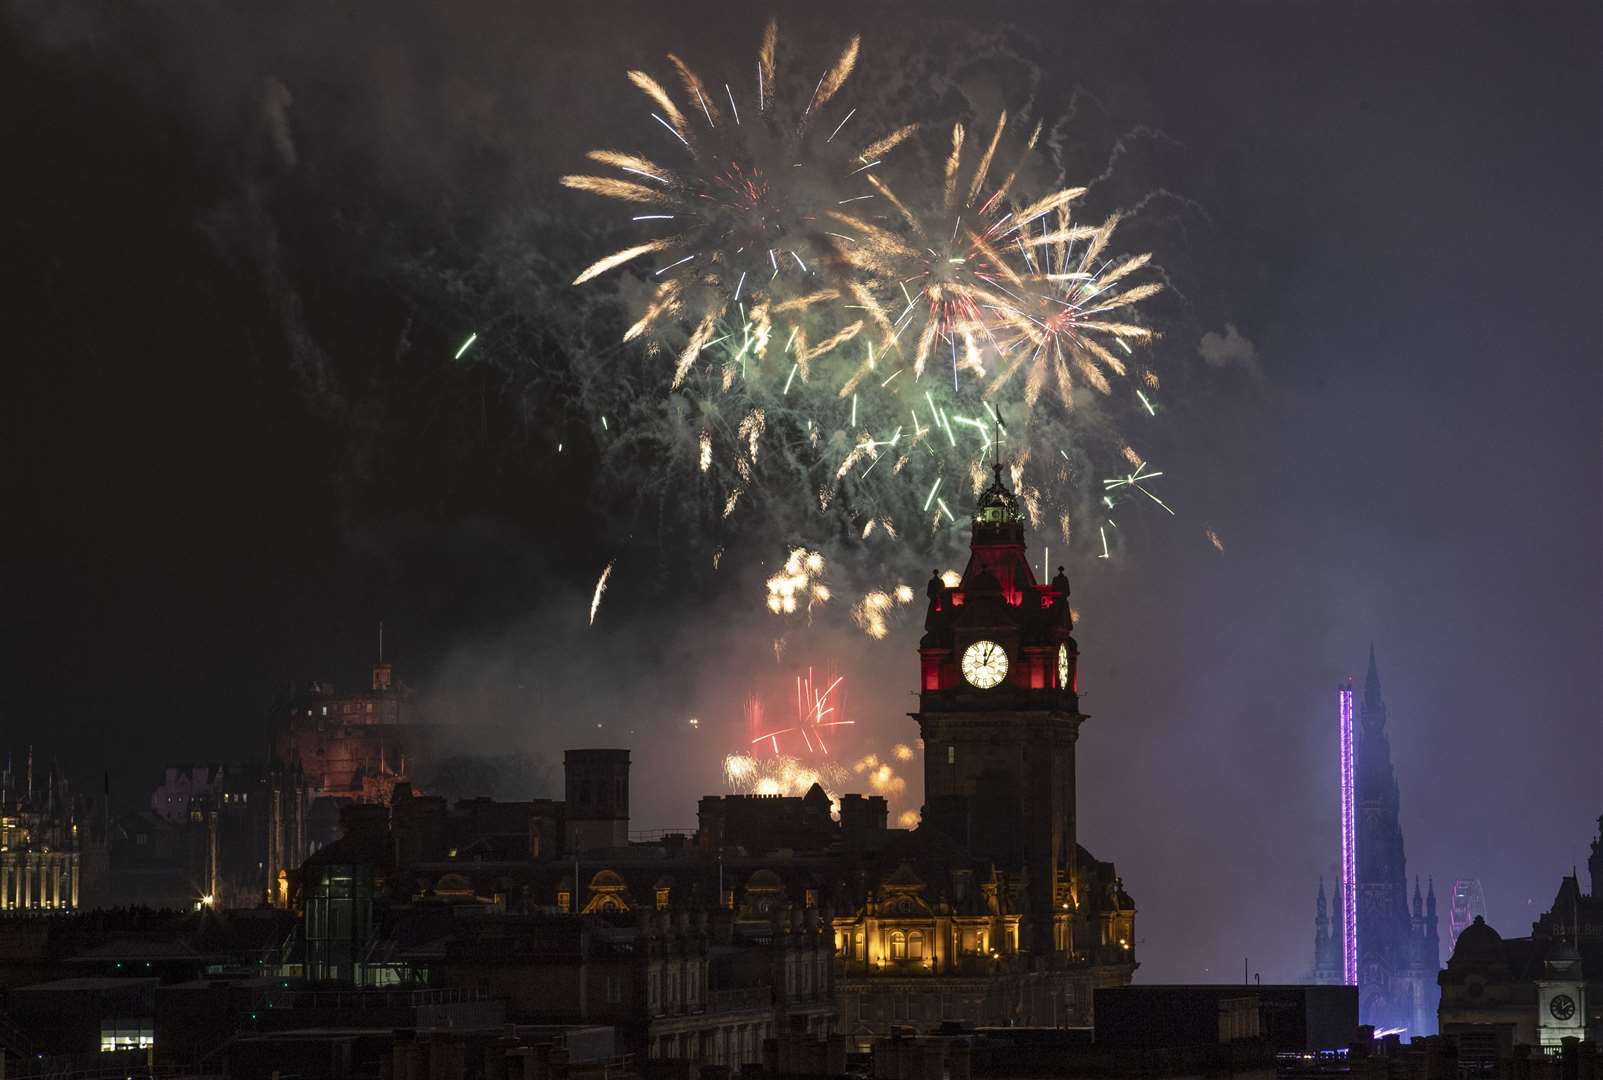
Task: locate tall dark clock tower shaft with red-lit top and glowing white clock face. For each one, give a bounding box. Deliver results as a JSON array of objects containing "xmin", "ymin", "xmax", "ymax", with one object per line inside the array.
[{"xmin": 912, "ymin": 465, "xmax": 1083, "ymax": 955}]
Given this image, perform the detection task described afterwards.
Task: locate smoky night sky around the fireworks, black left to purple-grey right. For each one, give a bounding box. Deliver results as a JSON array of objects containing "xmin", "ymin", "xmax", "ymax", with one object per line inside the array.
[{"xmin": 0, "ymin": 2, "xmax": 1603, "ymax": 981}]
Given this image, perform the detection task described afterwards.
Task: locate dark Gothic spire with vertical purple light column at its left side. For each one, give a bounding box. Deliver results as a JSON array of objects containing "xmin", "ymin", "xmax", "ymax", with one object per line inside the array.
[{"xmin": 1314, "ymin": 647, "xmax": 1441, "ymax": 1037}]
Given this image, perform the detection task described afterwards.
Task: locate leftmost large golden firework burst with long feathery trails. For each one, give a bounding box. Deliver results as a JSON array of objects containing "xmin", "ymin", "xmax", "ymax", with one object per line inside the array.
[{"xmin": 563, "ymin": 21, "xmax": 914, "ymax": 388}]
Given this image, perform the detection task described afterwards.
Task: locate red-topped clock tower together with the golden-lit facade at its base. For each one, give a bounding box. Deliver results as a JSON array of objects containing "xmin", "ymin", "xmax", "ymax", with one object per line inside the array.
[{"xmin": 835, "ymin": 465, "xmax": 1137, "ymax": 1042}]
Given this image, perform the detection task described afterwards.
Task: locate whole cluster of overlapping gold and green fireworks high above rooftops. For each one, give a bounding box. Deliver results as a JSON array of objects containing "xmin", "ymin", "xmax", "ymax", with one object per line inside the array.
[{"xmin": 564, "ymin": 22, "xmax": 1169, "ymax": 592}]
